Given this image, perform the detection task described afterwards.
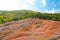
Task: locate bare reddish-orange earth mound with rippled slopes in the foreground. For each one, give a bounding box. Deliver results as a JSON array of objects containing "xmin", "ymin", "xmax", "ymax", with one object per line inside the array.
[{"xmin": 0, "ymin": 18, "xmax": 60, "ymax": 40}]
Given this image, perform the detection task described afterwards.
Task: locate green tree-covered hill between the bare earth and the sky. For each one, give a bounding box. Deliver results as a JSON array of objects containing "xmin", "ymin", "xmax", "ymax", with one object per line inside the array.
[{"xmin": 0, "ymin": 10, "xmax": 60, "ymax": 24}]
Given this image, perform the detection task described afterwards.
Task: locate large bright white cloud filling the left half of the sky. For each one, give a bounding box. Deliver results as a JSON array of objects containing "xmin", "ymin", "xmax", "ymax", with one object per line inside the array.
[{"xmin": 0, "ymin": 0, "xmax": 35, "ymax": 10}]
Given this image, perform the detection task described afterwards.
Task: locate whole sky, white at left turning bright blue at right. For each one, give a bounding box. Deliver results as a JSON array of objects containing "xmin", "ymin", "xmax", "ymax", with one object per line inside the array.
[{"xmin": 0, "ymin": 0, "xmax": 60, "ymax": 13}]
